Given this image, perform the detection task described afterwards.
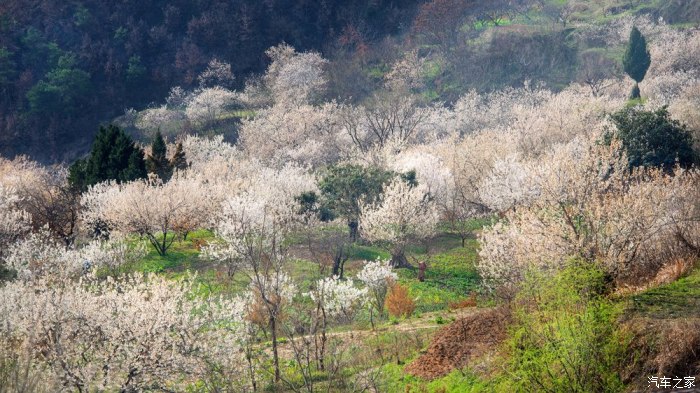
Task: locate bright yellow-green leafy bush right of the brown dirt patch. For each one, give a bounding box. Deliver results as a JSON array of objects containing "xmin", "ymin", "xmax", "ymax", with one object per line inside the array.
[{"xmin": 506, "ymin": 260, "xmax": 629, "ymax": 392}]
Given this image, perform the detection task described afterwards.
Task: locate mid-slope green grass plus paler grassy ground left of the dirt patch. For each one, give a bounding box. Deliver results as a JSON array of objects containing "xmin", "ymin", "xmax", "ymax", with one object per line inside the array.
[{"xmin": 111, "ymin": 221, "xmax": 485, "ymax": 391}]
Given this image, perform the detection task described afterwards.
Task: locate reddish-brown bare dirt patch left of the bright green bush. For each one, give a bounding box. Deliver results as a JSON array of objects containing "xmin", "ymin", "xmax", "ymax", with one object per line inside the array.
[{"xmin": 406, "ymin": 308, "xmax": 510, "ymax": 379}]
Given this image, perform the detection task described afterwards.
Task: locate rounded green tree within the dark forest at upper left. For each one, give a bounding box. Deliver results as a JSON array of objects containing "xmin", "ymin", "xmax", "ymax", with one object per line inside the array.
[{"xmin": 27, "ymin": 54, "xmax": 92, "ymax": 114}]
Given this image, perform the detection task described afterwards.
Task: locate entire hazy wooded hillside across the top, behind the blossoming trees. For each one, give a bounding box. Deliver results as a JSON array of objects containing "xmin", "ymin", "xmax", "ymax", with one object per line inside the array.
[{"xmin": 5, "ymin": 0, "xmax": 699, "ymax": 162}]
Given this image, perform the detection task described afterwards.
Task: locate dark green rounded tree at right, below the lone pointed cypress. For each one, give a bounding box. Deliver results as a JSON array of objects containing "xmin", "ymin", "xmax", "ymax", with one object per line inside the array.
[{"xmin": 606, "ymin": 107, "xmax": 696, "ymax": 169}]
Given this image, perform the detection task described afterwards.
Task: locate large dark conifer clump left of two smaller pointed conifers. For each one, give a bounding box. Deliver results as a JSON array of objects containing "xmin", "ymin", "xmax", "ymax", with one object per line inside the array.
[{"xmin": 68, "ymin": 125, "xmax": 146, "ymax": 191}]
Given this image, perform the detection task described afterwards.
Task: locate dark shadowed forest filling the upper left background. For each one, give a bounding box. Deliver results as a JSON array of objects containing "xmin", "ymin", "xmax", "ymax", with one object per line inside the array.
[{"xmin": 0, "ymin": 0, "xmax": 418, "ymax": 161}]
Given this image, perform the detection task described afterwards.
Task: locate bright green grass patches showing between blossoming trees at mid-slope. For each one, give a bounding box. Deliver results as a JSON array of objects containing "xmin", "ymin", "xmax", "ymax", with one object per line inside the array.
[{"xmin": 119, "ymin": 221, "xmax": 485, "ymax": 313}]
